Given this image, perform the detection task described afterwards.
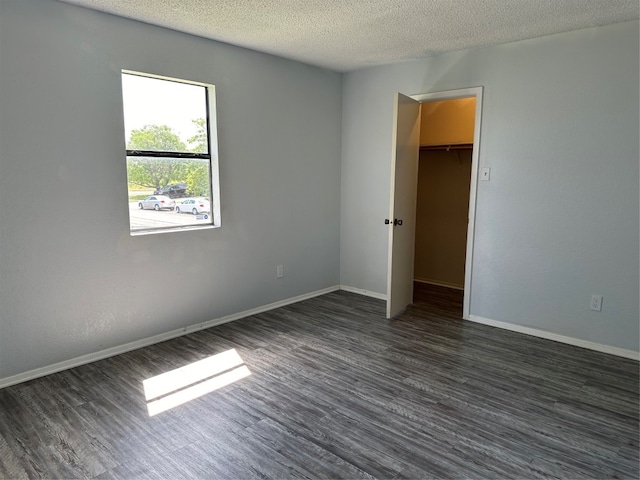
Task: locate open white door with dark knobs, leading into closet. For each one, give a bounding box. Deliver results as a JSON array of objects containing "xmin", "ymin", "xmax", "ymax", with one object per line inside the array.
[{"xmin": 387, "ymin": 93, "xmax": 420, "ymax": 318}]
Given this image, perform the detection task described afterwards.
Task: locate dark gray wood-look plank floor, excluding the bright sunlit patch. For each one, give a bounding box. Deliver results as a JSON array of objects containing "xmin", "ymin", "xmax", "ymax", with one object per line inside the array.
[{"xmin": 0, "ymin": 286, "xmax": 639, "ymax": 479}]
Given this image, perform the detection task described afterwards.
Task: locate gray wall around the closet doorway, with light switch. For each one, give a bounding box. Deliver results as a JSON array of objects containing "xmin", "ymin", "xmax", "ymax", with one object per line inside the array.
[{"xmin": 340, "ymin": 21, "xmax": 639, "ymax": 351}]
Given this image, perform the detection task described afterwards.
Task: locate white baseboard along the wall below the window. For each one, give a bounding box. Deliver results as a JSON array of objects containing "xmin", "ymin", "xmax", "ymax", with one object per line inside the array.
[{"xmin": 0, "ymin": 285, "xmax": 340, "ymax": 389}]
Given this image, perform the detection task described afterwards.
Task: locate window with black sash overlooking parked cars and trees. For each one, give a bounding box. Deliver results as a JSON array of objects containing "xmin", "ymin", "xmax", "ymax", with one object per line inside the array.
[{"xmin": 122, "ymin": 71, "xmax": 220, "ymax": 235}]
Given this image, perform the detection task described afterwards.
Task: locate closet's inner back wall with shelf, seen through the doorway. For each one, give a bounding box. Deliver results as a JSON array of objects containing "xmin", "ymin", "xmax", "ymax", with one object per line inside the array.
[{"xmin": 414, "ymin": 97, "xmax": 476, "ymax": 289}]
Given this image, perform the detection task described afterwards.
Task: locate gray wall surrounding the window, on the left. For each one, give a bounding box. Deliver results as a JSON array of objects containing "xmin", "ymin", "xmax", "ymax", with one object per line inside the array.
[{"xmin": 0, "ymin": 0, "xmax": 341, "ymax": 379}]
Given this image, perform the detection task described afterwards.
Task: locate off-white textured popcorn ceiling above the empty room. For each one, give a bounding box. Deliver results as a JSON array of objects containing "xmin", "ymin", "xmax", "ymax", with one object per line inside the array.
[{"xmin": 60, "ymin": 0, "xmax": 639, "ymax": 72}]
